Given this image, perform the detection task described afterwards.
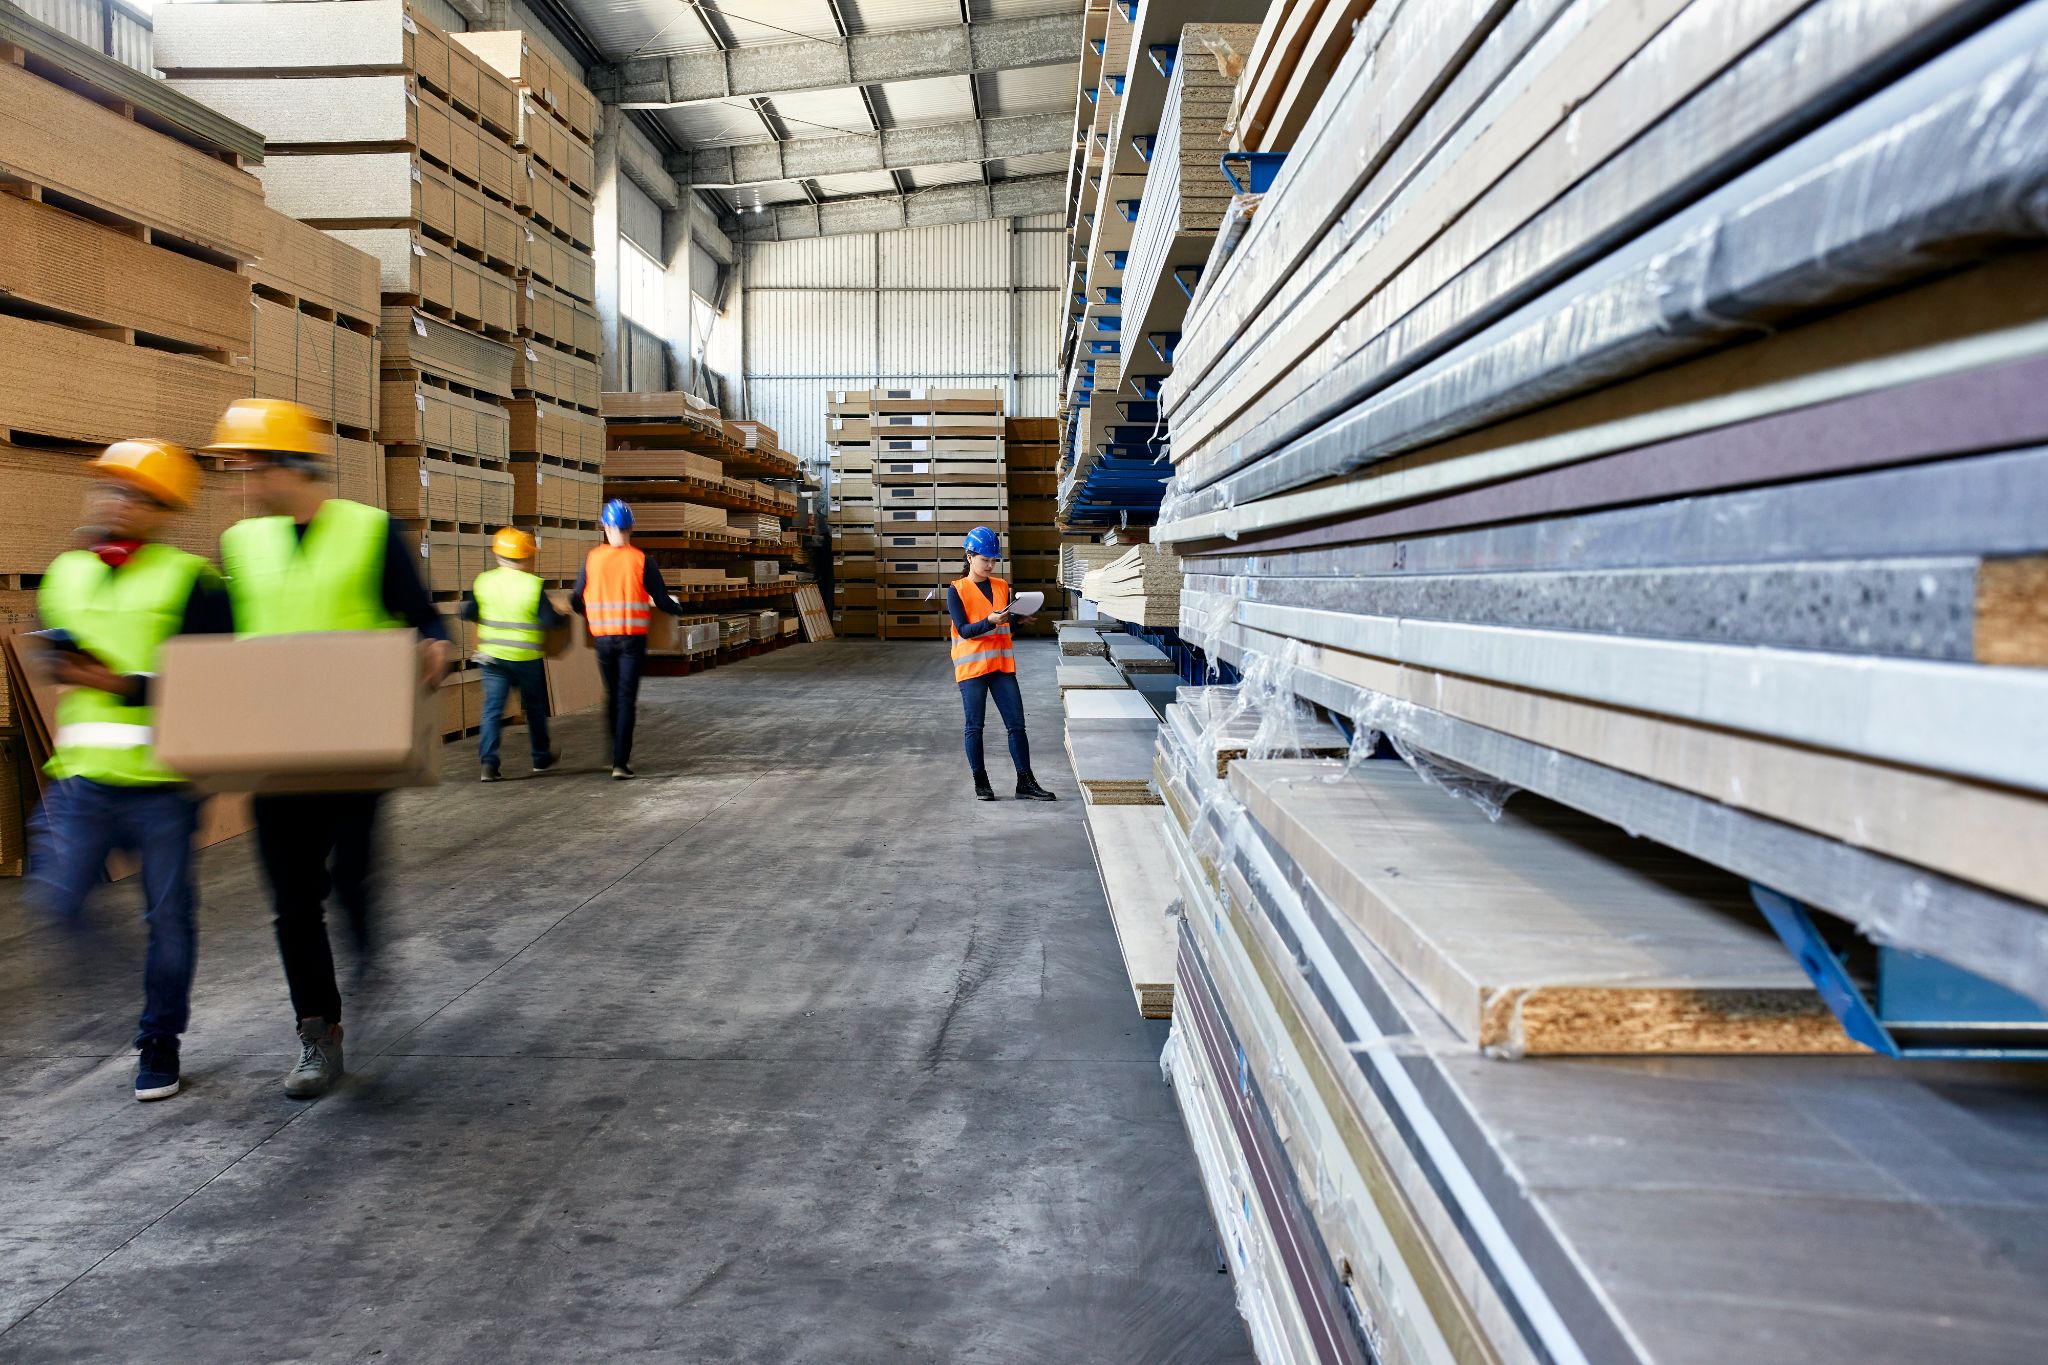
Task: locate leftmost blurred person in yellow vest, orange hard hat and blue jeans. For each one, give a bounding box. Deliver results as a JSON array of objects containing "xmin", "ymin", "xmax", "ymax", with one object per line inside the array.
[{"xmin": 29, "ymin": 440, "xmax": 227, "ymax": 1099}]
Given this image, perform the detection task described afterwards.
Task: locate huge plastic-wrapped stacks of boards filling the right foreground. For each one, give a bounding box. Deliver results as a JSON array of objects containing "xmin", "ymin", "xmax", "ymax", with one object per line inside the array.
[{"xmin": 1122, "ymin": 0, "xmax": 2048, "ymax": 1363}]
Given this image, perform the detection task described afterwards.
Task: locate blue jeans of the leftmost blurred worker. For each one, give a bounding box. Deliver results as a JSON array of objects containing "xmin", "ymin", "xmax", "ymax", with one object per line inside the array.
[{"xmin": 29, "ymin": 778, "xmax": 199, "ymax": 1046}]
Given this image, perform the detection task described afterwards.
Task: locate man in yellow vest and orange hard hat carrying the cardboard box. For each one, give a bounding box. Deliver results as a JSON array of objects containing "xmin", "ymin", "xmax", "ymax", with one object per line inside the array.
[{"xmin": 207, "ymin": 399, "xmax": 451, "ymax": 1099}]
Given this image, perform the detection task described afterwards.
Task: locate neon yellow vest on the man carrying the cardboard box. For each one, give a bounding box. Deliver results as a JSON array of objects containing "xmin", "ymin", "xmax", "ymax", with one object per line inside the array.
[{"xmin": 221, "ymin": 497, "xmax": 403, "ymax": 636}]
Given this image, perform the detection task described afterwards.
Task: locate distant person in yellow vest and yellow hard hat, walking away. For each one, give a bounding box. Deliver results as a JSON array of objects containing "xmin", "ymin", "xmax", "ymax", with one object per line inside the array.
[{"xmin": 463, "ymin": 526, "xmax": 569, "ymax": 782}]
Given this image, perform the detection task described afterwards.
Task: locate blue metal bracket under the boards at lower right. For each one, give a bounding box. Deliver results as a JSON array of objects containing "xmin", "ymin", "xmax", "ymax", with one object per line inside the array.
[{"xmin": 1749, "ymin": 882, "xmax": 2048, "ymax": 1062}]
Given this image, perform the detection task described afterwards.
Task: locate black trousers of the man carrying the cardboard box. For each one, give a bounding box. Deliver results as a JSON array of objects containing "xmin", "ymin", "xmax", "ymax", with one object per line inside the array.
[{"xmin": 252, "ymin": 792, "xmax": 383, "ymax": 1023}]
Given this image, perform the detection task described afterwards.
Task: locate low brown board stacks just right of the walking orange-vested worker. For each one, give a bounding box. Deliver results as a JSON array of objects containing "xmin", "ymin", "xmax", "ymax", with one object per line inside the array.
[{"xmin": 598, "ymin": 393, "xmax": 797, "ymax": 661}]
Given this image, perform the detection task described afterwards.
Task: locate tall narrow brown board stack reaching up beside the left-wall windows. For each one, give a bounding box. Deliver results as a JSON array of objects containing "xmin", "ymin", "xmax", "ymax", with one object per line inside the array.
[{"xmin": 453, "ymin": 29, "xmax": 604, "ymax": 581}]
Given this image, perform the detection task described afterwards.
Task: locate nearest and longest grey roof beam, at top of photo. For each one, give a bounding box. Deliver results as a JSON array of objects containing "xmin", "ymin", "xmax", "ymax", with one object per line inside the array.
[{"xmin": 586, "ymin": 14, "xmax": 1081, "ymax": 108}]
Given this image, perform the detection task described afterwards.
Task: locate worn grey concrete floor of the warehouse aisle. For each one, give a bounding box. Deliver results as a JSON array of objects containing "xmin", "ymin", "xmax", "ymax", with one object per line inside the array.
[{"xmin": 0, "ymin": 641, "xmax": 1249, "ymax": 1365}]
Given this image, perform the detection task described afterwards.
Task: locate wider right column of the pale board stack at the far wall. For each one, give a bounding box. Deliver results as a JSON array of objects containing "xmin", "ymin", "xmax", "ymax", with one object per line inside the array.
[{"xmin": 868, "ymin": 389, "xmax": 1010, "ymax": 641}]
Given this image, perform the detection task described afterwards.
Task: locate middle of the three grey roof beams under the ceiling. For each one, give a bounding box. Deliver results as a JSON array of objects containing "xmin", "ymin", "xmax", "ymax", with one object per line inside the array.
[{"xmin": 668, "ymin": 113, "xmax": 1073, "ymax": 190}]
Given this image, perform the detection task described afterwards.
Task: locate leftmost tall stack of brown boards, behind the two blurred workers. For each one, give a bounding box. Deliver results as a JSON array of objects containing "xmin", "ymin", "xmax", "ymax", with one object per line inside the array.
[{"xmin": 0, "ymin": 14, "xmax": 266, "ymax": 573}]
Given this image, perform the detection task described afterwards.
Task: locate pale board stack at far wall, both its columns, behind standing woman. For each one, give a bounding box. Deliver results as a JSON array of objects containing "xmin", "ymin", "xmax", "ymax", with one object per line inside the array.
[{"xmin": 825, "ymin": 385, "xmax": 1010, "ymax": 641}]
